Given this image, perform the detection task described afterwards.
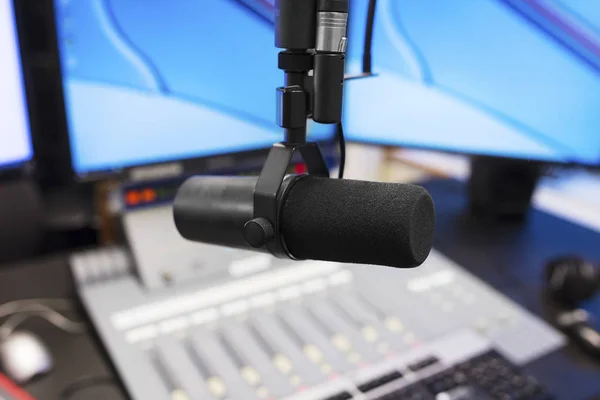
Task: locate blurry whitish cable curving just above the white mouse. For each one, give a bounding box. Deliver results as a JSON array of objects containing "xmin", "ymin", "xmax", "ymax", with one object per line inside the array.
[{"xmin": 0, "ymin": 304, "xmax": 86, "ymax": 341}]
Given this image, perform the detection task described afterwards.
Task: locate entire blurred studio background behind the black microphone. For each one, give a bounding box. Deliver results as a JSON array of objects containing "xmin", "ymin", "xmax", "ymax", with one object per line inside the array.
[{"xmin": 0, "ymin": 0, "xmax": 600, "ymax": 400}]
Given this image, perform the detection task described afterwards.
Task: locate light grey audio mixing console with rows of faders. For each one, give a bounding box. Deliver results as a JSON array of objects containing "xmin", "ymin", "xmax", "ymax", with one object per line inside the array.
[{"xmin": 71, "ymin": 205, "xmax": 564, "ymax": 400}]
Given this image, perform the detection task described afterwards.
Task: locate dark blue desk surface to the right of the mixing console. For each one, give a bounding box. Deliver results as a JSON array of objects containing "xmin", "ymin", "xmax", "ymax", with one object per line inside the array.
[{"xmin": 425, "ymin": 180, "xmax": 600, "ymax": 400}]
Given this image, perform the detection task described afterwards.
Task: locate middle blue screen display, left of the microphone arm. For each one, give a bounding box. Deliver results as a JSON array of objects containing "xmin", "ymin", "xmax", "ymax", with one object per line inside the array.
[{"xmin": 55, "ymin": 0, "xmax": 333, "ymax": 174}]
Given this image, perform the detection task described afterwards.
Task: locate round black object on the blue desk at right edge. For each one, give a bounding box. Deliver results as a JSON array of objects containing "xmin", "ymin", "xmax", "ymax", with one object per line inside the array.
[{"xmin": 546, "ymin": 256, "xmax": 600, "ymax": 306}]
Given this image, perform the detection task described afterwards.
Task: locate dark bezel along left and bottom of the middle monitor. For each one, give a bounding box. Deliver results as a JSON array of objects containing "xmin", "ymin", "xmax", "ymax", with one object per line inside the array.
[{"xmin": 47, "ymin": 0, "xmax": 338, "ymax": 183}]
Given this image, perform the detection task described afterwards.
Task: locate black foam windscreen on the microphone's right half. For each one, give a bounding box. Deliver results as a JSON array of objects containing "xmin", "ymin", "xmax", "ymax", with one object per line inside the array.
[{"xmin": 281, "ymin": 176, "xmax": 435, "ymax": 268}]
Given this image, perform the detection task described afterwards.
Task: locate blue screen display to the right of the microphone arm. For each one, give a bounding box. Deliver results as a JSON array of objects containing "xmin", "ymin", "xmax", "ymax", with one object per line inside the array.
[{"xmin": 344, "ymin": 0, "xmax": 600, "ymax": 165}]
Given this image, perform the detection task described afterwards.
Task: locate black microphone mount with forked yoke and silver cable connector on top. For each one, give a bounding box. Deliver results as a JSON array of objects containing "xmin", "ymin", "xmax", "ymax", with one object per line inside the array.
[{"xmin": 244, "ymin": 0, "xmax": 348, "ymax": 258}]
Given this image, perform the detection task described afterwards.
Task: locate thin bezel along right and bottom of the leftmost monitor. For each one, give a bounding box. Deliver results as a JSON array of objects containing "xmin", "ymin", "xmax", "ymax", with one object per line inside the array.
[{"xmin": 0, "ymin": 0, "xmax": 35, "ymax": 181}]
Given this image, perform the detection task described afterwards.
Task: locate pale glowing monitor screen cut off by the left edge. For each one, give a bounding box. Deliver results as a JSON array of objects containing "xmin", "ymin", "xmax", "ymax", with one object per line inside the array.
[{"xmin": 0, "ymin": 1, "xmax": 33, "ymax": 174}]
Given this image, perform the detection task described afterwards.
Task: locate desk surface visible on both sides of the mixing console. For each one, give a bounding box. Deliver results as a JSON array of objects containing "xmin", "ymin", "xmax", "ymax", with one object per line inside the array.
[{"xmin": 0, "ymin": 180, "xmax": 600, "ymax": 400}]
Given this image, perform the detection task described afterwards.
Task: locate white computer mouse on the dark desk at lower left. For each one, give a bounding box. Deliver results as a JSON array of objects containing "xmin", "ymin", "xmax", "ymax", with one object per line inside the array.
[{"xmin": 0, "ymin": 331, "xmax": 52, "ymax": 384}]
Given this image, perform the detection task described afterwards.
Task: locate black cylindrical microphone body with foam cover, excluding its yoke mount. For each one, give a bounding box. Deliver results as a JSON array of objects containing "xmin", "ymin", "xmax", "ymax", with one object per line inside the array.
[{"xmin": 174, "ymin": 175, "xmax": 435, "ymax": 268}]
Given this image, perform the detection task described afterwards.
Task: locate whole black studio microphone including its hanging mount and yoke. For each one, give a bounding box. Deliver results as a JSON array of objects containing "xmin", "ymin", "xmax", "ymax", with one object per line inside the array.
[{"xmin": 173, "ymin": 0, "xmax": 435, "ymax": 268}]
